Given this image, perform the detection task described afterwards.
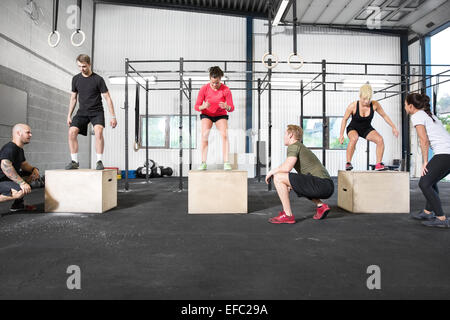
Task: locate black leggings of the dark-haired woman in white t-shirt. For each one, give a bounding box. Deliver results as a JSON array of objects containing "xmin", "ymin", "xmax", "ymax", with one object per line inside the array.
[{"xmin": 419, "ymin": 154, "xmax": 450, "ymax": 216}]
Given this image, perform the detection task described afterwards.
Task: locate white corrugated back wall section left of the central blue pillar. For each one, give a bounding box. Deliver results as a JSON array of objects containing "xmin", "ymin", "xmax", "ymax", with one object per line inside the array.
[{"xmin": 92, "ymin": 4, "xmax": 246, "ymax": 175}]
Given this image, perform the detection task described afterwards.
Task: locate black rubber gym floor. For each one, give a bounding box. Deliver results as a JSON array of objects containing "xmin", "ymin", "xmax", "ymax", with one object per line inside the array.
[{"xmin": 0, "ymin": 178, "xmax": 450, "ymax": 300}]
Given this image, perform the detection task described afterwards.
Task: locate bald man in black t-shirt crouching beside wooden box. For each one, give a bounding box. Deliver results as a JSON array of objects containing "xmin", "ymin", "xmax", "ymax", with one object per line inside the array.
[{"xmin": 0, "ymin": 123, "xmax": 39, "ymax": 212}]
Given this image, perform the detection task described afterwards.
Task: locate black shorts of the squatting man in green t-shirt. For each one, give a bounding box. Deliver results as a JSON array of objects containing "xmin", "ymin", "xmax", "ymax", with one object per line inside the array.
[{"xmin": 289, "ymin": 172, "xmax": 334, "ymax": 200}]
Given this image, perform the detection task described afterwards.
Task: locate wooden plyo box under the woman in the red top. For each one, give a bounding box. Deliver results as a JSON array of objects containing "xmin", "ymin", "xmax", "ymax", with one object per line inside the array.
[{"xmin": 188, "ymin": 170, "xmax": 248, "ymax": 214}]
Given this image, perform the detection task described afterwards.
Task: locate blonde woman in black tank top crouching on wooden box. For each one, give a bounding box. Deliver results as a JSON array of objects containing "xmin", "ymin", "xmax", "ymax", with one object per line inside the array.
[{"xmin": 339, "ymin": 84, "xmax": 399, "ymax": 171}]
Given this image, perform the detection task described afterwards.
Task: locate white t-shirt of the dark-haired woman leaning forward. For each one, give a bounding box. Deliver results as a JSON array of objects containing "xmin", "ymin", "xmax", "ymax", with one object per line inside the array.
[{"xmin": 411, "ymin": 110, "xmax": 450, "ymax": 154}]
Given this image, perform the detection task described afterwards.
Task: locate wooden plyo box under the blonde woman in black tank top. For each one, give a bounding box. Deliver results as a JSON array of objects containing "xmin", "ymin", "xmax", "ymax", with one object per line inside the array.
[{"xmin": 338, "ymin": 170, "xmax": 409, "ymax": 213}]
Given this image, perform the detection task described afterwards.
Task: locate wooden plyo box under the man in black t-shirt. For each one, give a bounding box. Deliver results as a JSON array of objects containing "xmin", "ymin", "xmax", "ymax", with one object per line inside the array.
[{"xmin": 45, "ymin": 169, "xmax": 117, "ymax": 213}]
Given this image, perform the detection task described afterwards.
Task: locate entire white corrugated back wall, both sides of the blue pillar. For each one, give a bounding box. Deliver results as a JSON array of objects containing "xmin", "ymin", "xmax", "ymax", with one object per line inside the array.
[{"xmin": 93, "ymin": 4, "xmax": 401, "ymax": 175}]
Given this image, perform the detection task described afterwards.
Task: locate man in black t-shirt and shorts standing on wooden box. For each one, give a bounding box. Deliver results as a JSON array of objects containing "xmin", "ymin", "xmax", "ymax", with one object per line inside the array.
[{"xmin": 66, "ymin": 54, "xmax": 117, "ymax": 170}]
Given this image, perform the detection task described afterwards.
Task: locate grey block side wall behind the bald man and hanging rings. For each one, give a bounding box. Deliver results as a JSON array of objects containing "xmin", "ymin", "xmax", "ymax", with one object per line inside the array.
[{"xmin": 0, "ymin": 0, "xmax": 94, "ymax": 171}]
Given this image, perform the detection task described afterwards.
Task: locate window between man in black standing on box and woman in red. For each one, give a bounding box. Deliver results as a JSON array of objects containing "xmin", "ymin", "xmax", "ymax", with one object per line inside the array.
[{"xmin": 139, "ymin": 115, "xmax": 197, "ymax": 149}]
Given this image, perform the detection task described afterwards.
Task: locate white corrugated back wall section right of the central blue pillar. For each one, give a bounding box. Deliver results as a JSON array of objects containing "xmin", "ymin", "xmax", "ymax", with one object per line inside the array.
[{"xmin": 254, "ymin": 20, "xmax": 401, "ymax": 176}]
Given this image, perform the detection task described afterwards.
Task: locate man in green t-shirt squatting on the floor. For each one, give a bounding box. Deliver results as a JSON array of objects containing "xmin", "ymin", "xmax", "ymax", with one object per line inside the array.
[{"xmin": 266, "ymin": 125, "xmax": 334, "ymax": 223}]
